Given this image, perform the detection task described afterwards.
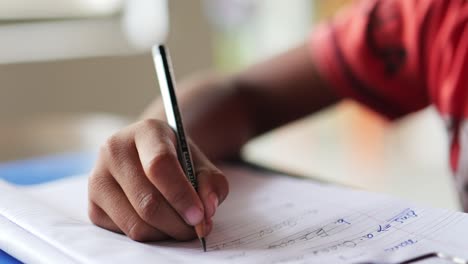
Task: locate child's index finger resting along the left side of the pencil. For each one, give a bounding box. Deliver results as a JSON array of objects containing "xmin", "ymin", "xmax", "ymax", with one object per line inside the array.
[{"xmin": 135, "ymin": 120, "xmax": 204, "ymax": 226}]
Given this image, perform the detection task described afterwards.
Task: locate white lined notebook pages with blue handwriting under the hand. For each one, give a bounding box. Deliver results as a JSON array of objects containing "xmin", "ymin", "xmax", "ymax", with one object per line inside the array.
[{"xmin": 0, "ymin": 167, "xmax": 468, "ymax": 264}]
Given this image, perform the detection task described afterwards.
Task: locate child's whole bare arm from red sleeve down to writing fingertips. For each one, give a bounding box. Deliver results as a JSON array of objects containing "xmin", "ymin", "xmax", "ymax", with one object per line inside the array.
[{"xmin": 89, "ymin": 41, "xmax": 338, "ymax": 241}]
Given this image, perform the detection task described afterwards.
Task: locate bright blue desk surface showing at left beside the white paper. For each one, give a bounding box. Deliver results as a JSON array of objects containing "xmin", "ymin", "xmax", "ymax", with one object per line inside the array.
[{"xmin": 0, "ymin": 152, "xmax": 96, "ymax": 264}]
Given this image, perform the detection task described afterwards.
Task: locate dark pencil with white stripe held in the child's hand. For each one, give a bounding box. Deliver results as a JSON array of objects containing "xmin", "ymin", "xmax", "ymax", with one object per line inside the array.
[{"xmin": 152, "ymin": 45, "xmax": 206, "ymax": 252}]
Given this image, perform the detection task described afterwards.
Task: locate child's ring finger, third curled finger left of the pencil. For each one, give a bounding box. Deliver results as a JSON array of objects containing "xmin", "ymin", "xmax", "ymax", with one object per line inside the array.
[{"xmin": 89, "ymin": 166, "xmax": 167, "ymax": 241}]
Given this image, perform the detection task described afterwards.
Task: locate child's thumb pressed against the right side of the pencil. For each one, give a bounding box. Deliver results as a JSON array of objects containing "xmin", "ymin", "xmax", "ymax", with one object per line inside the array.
[{"xmin": 190, "ymin": 143, "xmax": 229, "ymax": 219}]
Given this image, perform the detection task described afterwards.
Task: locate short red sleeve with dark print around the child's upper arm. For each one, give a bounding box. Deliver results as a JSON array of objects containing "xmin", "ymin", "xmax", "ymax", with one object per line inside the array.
[{"xmin": 310, "ymin": 0, "xmax": 430, "ymax": 119}]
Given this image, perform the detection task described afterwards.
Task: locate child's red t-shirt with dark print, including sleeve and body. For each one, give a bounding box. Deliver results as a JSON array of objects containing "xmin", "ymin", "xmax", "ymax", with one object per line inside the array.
[{"xmin": 311, "ymin": 0, "xmax": 468, "ymax": 210}]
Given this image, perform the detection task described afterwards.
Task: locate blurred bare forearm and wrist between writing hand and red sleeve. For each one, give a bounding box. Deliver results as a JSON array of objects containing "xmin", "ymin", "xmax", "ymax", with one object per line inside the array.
[{"xmin": 143, "ymin": 45, "xmax": 338, "ymax": 159}]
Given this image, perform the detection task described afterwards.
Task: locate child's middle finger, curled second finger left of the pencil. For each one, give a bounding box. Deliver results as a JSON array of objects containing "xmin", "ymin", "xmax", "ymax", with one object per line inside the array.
[{"xmin": 101, "ymin": 125, "xmax": 195, "ymax": 240}]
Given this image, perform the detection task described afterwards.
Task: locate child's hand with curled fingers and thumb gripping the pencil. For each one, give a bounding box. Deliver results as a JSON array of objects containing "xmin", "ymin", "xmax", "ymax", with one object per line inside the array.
[{"xmin": 89, "ymin": 119, "xmax": 228, "ymax": 241}]
